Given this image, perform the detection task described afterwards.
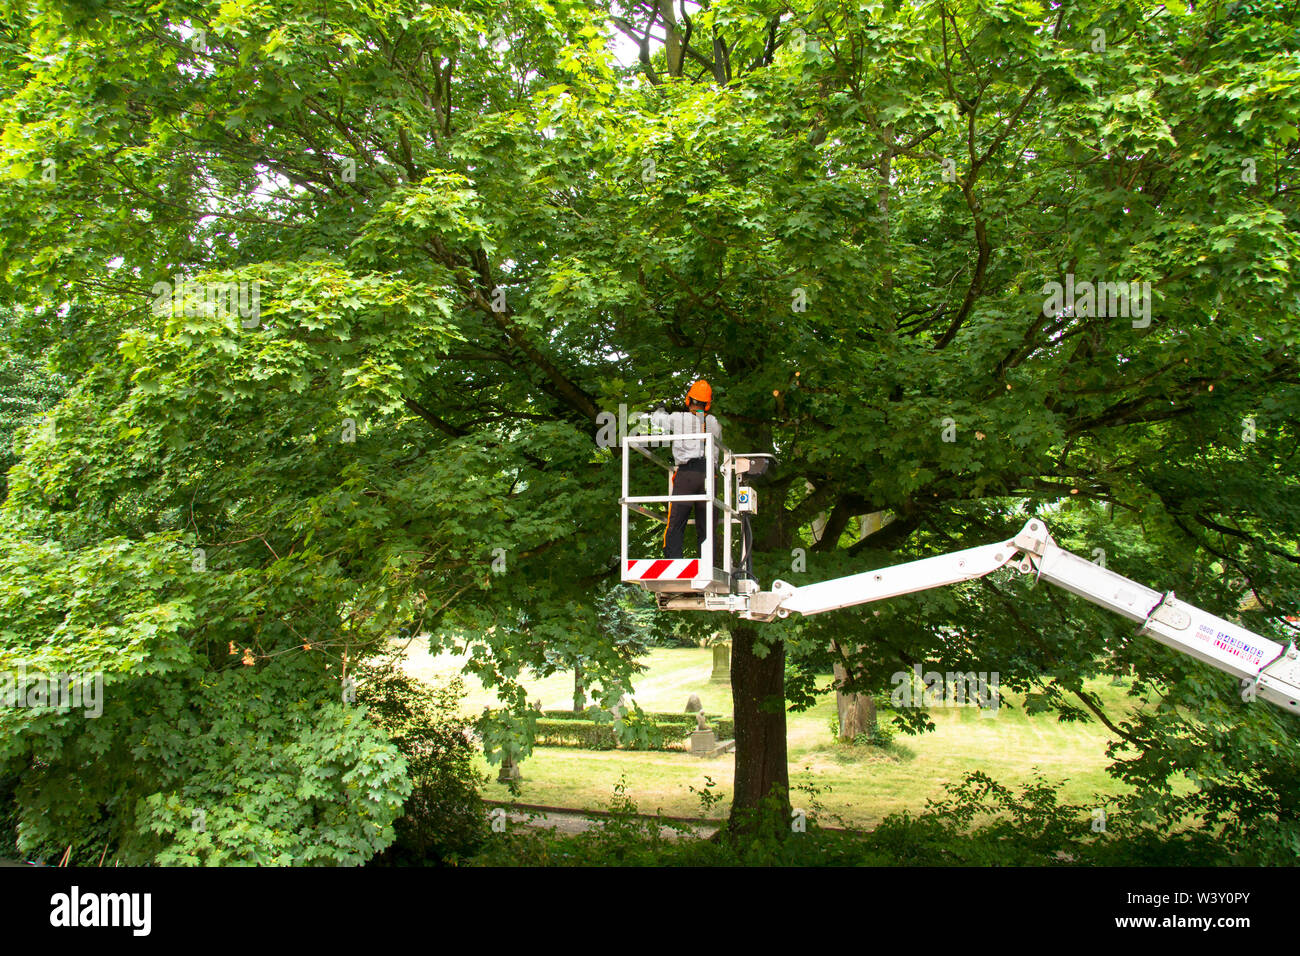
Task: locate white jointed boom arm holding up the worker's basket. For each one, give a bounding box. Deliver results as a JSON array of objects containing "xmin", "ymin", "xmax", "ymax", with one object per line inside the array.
[{"xmin": 748, "ymin": 520, "xmax": 1300, "ymax": 713}]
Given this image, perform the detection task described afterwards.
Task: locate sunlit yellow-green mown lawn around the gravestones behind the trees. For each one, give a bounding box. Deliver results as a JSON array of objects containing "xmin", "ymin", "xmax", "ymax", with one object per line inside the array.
[{"xmin": 406, "ymin": 644, "xmax": 1127, "ymax": 827}]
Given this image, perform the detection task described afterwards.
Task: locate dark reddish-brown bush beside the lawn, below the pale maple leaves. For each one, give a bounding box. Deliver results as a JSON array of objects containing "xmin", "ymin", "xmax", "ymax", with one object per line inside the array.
[{"xmin": 358, "ymin": 667, "xmax": 488, "ymax": 866}]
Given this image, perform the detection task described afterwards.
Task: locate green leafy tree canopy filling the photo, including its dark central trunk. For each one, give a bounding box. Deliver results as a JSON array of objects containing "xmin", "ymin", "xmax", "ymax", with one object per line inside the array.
[{"xmin": 0, "ymin": 0, "xmax": 1300, "ymax": 861}]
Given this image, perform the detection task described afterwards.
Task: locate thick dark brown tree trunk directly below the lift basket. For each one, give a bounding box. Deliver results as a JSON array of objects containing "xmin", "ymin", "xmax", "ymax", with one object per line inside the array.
[{"xmin": 729, "ymin": 622, "xmax": 790, "ymax": 832}]
